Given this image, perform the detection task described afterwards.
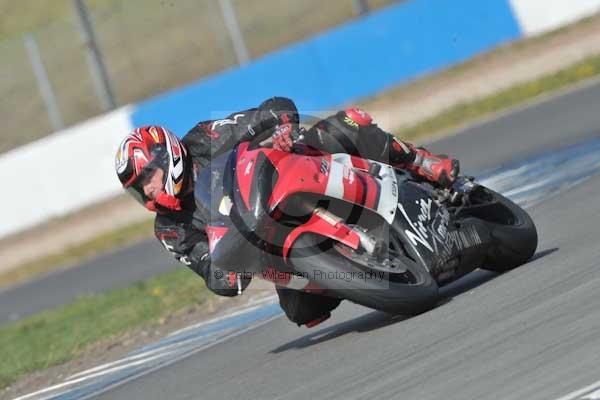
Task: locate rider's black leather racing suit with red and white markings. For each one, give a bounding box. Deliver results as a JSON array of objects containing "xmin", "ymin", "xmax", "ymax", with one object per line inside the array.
[{"xmin": 155, "ymin": 97, "xmax": 415, "ymax": 325}]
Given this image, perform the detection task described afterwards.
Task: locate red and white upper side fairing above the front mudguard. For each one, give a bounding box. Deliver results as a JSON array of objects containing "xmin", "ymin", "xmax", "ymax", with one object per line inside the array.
[{"xmin": 235, "ymin": 143, "xmax": 398, "ymax": 223}]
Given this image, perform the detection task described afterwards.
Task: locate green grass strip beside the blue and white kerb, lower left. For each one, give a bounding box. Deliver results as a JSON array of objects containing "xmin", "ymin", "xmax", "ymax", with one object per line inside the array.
[{"xmin": 0, "ymin": 268, "xmax": 212, "ymax": 388}]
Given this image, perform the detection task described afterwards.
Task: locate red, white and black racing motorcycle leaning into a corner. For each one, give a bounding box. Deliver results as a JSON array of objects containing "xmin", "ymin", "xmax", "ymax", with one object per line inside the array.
[{"xmin": 195, "ymin": 138, "xmax": 537, "ymax": 315}]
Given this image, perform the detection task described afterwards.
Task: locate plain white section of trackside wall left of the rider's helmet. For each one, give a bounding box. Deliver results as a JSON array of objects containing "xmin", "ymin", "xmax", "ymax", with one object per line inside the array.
[{"xmin": 0, "ymin": 106, "xmax": 132, "ymax": 236}]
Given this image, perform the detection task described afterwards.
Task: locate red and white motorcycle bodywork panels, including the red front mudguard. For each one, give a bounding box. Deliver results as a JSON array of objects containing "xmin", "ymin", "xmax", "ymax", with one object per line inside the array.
[{"xmin": 236, "ymin": 143, "xmax": 398, "ymax": 258}]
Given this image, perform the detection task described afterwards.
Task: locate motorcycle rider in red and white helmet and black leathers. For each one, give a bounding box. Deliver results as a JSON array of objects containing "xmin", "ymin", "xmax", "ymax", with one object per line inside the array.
[{"xmin": 115, "ymin": 97, "xmax": 459, "ymax": 327}]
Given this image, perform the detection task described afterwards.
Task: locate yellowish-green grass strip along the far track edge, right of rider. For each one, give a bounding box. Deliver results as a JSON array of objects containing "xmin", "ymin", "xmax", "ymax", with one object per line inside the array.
[{"xmin": 398, "ymin": 56, "xmax": 600, "ymax": 139}]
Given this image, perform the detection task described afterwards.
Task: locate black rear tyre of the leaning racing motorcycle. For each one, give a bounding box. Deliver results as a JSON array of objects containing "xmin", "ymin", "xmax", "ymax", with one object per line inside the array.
[{"xmin": 480, "ymin": 188, "xmax": 538, "ymax": 272}]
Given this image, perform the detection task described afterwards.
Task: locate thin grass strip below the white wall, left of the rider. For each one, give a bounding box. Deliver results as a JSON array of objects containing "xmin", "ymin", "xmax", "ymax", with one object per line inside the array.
[{"xmin": 0, "ymin": 220, "xmax": 154, "ymax": 288}]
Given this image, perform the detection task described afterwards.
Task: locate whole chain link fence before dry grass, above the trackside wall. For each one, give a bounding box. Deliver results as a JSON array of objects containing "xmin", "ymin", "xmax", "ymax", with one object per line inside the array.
[{"xmin": 0, "ymin": 0, "xmax": 398, "ymax": 152}]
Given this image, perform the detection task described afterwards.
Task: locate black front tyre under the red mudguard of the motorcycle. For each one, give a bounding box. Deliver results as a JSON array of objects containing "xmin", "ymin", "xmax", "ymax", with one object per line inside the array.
[{"xmin": 290, "ymin": 234, "xmax": 438, "ymax": 315}]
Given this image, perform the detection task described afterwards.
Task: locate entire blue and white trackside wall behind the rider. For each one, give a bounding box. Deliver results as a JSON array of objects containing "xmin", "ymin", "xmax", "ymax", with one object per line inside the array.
[{"xmin": 0, "ymin": 0, "xmax": 600, "ymax": 236}]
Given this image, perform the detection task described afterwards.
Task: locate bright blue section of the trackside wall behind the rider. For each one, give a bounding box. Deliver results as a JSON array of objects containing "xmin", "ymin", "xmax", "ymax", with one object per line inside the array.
[{"xmin": 132, "ymin": 0, "xmax": 522, "ymax": 135}]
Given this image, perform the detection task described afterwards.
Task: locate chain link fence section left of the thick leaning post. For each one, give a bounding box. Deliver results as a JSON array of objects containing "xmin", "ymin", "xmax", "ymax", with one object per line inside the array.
[{"xmin": 0, "ymin": 17, "xmax": 102, "ymax": 152}]
